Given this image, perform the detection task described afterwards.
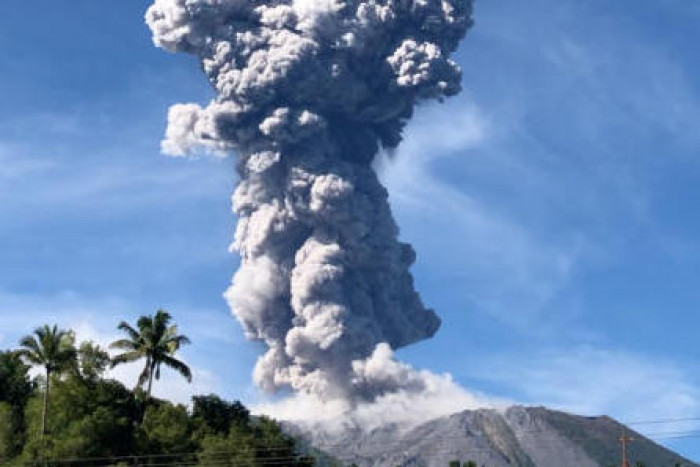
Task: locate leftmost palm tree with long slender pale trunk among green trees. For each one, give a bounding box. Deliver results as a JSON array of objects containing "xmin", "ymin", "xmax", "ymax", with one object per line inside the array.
[{"xmin": 18, "ymin": 325, "xmax": 76, "ymax": 438}]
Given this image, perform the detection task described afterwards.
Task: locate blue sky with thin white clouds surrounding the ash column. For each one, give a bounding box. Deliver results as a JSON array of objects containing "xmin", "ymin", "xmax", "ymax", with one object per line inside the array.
[{"xmin": 0, "ymin": 0, "xmax": 700, "ymax": 460}]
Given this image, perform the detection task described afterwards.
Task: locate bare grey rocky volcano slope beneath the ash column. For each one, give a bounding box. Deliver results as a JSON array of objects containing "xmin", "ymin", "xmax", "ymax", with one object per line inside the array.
[{"xmin": 286, "ymin": 407, "xmax": 697, "ymax": 467}]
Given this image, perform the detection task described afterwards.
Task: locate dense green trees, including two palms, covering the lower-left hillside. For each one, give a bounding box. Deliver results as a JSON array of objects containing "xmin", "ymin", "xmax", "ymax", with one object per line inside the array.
[{"xmin": 0, "ymin": 310, "xmax": 314, "ymax": 467}]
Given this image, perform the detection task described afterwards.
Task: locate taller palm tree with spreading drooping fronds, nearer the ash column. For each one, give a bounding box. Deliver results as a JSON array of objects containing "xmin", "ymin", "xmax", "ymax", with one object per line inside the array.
[{"xmin": 110, "ymin": 310, "xmax": 192, "ymax": 398}]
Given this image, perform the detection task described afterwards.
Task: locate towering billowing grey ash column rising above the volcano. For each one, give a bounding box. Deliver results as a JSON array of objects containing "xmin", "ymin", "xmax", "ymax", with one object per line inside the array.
[{"xmin": 146, "ymin": 0, "xmax": 472, "ymax": 401}]
